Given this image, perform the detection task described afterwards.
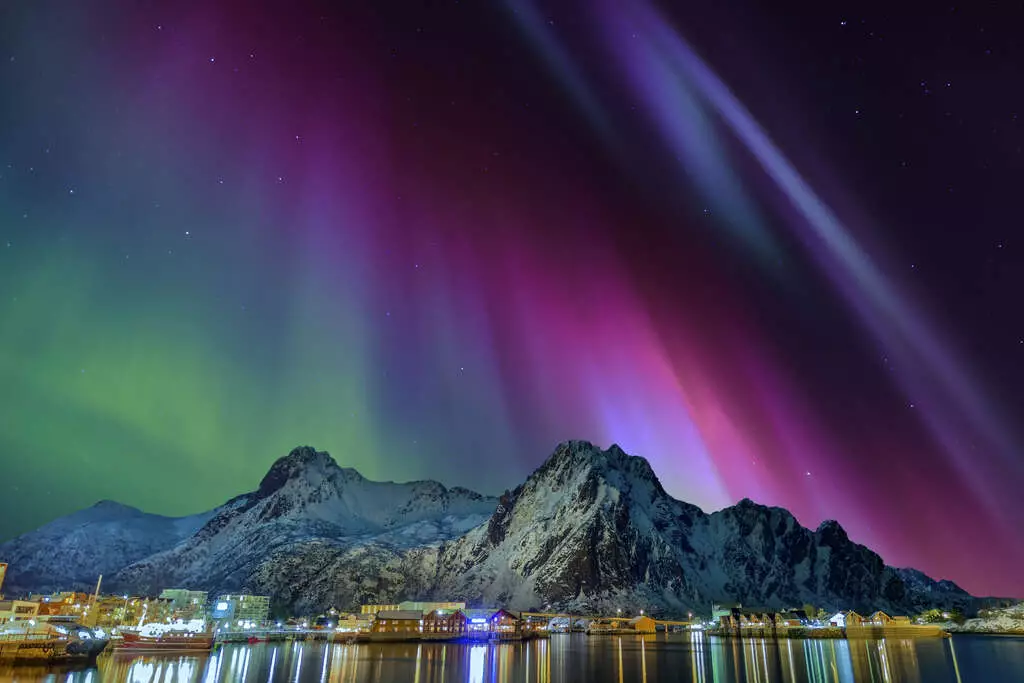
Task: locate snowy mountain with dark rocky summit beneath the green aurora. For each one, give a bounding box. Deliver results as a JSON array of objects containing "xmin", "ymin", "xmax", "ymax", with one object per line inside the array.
[{"xmin": 112, "ymin": 446, "xmax": 497, "ymax": 604}]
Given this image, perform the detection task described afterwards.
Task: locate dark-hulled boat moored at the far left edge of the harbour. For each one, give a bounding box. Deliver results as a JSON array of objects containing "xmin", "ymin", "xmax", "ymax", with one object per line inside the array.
[{"xmin": 0, "ymin": 620, "xmax": 109, "ymax": 663}]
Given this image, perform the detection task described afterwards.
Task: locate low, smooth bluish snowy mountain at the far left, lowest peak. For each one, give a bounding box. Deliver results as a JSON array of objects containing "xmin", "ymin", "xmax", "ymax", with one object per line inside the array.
[{"xmin": 0, "ymin": 501, "xmax": 212, "ymax": 594}]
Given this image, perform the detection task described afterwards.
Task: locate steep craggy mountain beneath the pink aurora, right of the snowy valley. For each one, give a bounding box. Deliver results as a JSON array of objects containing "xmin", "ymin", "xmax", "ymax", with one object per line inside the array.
[{"xmin": 435, "ymin": 441, "xmax": 972, "ymax": 614}]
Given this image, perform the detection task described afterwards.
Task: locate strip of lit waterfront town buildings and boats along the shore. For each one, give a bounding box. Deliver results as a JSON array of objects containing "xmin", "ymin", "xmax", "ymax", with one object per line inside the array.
[{"xmin": 0, "ymin": 564, "xmax": 999, "ymax": 660}]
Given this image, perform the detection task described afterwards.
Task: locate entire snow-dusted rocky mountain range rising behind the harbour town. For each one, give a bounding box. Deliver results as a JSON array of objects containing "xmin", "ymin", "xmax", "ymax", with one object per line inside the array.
[{"xmin": 0, "ymin": 441, "xmax": 972, "ymax": 614}]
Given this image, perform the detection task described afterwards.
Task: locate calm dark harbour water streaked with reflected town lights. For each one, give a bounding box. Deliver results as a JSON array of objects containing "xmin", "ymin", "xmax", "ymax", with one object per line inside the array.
[{"xmin": 0, "ymin": 634, "xmax": 1024, "ymax": 683}]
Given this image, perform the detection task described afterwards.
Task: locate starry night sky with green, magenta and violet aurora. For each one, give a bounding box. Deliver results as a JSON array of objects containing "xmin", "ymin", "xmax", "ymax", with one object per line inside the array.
[{"xmin": 0, "ymin": 0, "xmax": 1024, "ymax": 596}]
